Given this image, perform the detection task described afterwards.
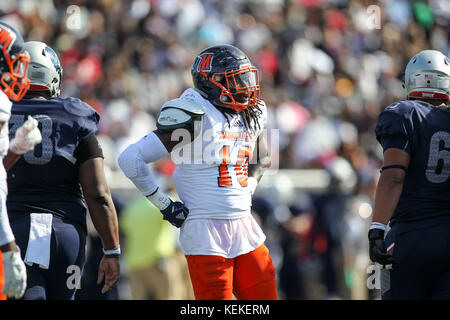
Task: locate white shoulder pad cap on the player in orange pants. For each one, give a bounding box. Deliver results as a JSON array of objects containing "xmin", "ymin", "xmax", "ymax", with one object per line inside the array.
[{"xmin": 156, "ymin": 98, "xmax": 205, "ymax": 131}]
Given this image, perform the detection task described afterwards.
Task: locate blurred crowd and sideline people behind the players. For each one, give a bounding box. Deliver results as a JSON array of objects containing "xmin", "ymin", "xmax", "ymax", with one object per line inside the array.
[{"xmin": 0, "ymin": 0, "xmax": 450, "ymax": 299}]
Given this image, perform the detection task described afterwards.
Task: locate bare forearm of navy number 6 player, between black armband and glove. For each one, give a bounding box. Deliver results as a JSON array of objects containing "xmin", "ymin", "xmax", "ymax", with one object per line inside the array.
[{"xmin": 372, "ymin": 172, "xmax": 403, "ymax": 224}]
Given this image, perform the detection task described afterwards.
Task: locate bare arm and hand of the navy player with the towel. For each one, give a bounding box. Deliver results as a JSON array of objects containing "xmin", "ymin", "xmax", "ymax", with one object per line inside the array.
[{"xmin": 79, "ymin": 158, "xmax": 120, "ymax": 293}]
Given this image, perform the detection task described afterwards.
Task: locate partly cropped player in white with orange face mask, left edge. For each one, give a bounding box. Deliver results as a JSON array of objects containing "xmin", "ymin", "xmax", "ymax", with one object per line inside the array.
[{"xmin": 0, "ymin": 22, "xmax": 42, "ymax": 299}]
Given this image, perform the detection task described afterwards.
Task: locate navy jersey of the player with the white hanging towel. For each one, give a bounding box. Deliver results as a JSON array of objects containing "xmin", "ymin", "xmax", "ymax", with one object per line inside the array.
[{"xmin": 7, "ymin": 98, "xmax": 100, "ymax": 226}]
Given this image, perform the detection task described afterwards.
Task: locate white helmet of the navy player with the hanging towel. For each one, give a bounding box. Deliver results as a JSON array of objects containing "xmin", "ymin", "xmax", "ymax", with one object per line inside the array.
[{"xmin": 24, "ymin": 41, "xmax": 63, "ymax": 97}]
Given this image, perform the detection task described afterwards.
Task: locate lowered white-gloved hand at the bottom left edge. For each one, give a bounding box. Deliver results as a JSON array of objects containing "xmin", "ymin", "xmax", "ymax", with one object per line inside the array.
[{"xmin": 2, "ymin": 251, "xmax": 27, "ymax": 299}]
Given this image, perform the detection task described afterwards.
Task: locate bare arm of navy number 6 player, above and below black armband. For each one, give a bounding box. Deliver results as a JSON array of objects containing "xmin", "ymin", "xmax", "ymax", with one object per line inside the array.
[{"xmin": 372, "ymin": 148, "xmax": 410, "ymax": 224}]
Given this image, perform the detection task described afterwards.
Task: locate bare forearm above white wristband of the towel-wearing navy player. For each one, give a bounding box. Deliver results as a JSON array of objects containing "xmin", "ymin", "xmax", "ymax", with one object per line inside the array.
[{"xmin": 85, "ymin": 191, "xmax": 119, "ymax": 250}]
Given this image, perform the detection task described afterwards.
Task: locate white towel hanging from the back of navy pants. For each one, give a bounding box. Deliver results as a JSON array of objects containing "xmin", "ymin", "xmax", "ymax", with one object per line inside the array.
[{"xmin": 24, "ymin": 213, "xmax": 53, "ymax": 269}]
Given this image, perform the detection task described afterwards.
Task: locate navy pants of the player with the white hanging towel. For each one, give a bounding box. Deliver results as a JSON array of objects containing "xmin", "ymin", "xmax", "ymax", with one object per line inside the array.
[{"xmin": 11, "ymin": 216, "xmax": 86, "ymax": 300}]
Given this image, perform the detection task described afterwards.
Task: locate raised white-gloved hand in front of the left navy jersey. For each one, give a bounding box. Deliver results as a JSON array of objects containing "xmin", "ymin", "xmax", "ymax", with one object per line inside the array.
[{"xmin": 9, "ymin": 116, "xmax": 42, "ymax": 154}]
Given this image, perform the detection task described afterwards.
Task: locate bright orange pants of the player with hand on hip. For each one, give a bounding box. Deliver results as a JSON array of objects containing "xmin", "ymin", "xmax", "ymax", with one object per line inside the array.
[{"xmin": 186, "ymin": 244, "xmax": 278, "ymax": 300}]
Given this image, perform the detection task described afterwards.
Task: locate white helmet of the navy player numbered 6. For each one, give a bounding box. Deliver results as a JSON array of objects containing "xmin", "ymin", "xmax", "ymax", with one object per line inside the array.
[{"xmin": 404, "ymin": 50, "xmax": 450, "ymax": 100}]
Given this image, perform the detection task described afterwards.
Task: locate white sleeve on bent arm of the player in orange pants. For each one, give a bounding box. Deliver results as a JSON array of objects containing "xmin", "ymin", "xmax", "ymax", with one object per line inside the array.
[{"xmin": 118, "ymin": 132, "xmax": 169, "ymax": 209}]
